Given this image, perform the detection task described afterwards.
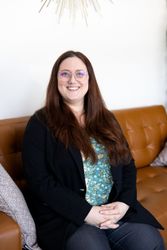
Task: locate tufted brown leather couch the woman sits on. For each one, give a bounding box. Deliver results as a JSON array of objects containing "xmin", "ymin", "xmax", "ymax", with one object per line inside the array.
[{"xmin": 0, "ymin": 105, "xmax": 167, "ymax": 250}]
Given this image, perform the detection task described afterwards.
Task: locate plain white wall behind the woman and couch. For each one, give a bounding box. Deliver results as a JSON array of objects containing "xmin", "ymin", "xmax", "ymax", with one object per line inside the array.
[{"xmin": 0, "ymin": 0, "xmax": 167, "ymax": 119}]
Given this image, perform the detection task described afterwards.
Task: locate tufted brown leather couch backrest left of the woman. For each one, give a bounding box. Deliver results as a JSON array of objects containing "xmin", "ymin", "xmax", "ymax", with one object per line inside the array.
[{"xmin": 0, "ymin": 117, "xmax": 29, "ymax": 191}]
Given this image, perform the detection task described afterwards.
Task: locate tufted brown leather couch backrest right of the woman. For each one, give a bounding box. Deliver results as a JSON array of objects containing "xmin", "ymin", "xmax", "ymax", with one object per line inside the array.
[{"xmin": 114, "ymin": 106, "xmax": 167, "ymax": 168}]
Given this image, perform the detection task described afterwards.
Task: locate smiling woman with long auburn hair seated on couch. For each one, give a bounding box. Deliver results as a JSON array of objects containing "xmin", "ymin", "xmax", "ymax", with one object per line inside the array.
[{"xmin": 23, "ymin": 51, "xmax": 165, "ymax": 250}]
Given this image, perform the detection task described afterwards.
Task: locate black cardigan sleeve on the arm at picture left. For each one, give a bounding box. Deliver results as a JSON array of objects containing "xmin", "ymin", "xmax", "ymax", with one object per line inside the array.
[{"xmin": 22, "ymin": 115, "xmax": 92, "ymax": 225}]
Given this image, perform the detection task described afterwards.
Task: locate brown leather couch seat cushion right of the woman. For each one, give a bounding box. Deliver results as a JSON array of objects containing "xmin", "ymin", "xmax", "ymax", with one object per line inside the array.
[{"xmin": 137, "ymin": 166, "xmax": 167, "ymax": 241}]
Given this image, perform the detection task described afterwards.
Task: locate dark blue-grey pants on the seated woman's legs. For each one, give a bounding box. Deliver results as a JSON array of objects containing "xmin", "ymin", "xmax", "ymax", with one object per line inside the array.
[{"xmin": 66, "ymin": 223, "xmax": 165, "ymax": 250}]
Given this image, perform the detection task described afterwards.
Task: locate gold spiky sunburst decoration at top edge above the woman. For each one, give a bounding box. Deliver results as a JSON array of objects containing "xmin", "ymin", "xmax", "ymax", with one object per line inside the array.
[{"xmin": 39, "ymin": 0, "xmax": 112, "ymax": 23}]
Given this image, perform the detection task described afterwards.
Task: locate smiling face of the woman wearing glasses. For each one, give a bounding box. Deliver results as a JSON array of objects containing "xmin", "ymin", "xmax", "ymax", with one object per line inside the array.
[{"xmin": 57, "ymin": 57, "xmax": 89, "ymax": 105}]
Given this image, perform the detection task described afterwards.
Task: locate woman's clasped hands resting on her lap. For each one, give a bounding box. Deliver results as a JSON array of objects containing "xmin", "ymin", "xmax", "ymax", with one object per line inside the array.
[{"xmin": 85, "ymin": 201, "xmax": 129, "ymax": 229}]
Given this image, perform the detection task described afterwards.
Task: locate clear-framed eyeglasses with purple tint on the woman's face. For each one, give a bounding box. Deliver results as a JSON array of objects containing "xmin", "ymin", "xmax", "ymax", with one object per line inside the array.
[{"xmin": 58, "ymin": 70, "xmax": 88, "ymax": 81}]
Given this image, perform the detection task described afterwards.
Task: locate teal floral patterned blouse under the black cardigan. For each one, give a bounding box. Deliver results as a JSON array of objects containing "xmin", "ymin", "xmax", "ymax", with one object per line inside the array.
[{"xmin": 83, "ymin": 138, "xmax": 113, "ymax": 205}]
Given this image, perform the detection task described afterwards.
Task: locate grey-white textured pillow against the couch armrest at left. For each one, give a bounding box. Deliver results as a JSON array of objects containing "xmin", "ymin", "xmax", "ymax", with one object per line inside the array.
[{"xmin": 0, "ymin": 164, "xmax": 41, "ymax": 250}]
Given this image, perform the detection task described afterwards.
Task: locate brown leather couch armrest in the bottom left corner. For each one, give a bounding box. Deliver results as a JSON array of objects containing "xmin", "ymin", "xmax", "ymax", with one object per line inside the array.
[{"xmin": 0, "ymin": 212, "xmax": 22, "ymax": 250}]
